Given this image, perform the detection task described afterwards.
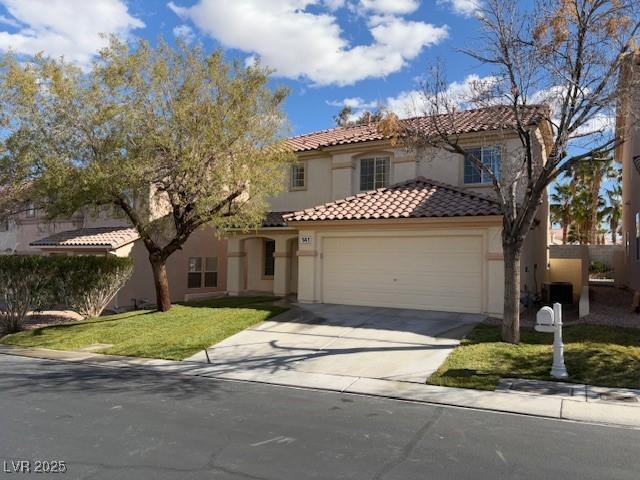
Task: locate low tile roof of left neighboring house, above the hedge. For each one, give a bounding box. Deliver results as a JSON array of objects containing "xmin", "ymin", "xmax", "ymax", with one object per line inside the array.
[{"xmin": 30, "ymin": 227, "xmax": 140, "ymax": 250}]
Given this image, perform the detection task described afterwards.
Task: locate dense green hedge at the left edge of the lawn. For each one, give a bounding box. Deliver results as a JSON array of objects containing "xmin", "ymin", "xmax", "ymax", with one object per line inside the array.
[{"xmin": 0, "ymin": 255, "xmax": 133, "ymax": 333}]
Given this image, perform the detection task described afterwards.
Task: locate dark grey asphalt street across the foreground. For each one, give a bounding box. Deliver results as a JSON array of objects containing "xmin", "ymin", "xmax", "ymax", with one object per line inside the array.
[{"xmin": 0, "ymin": 355, "xmax": 640, "ymax": 480}]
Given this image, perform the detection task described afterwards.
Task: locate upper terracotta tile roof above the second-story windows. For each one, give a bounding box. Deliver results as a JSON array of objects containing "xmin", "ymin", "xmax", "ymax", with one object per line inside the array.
[{"xmin": 287, "ymin": 105, "xmax": 548, "ymax": 152}]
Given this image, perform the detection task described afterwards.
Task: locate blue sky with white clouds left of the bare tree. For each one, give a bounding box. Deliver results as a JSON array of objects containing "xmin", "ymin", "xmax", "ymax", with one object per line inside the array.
[{"xmin": 0, "ymin": 0, "xmax": 486, "ymax": 134}]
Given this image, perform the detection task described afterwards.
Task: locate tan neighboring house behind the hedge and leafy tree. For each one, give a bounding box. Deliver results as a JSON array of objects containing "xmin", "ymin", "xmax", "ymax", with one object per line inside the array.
[{"xmin": 12, "ymin": 192, "xmax": 227, "ymax": 308}]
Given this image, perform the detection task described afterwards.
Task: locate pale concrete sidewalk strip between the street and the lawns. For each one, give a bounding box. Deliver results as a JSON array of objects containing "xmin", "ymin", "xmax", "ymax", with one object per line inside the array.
[{"xmin": 0, "ymin": 345, "xmax": 640, "ymax": 428}]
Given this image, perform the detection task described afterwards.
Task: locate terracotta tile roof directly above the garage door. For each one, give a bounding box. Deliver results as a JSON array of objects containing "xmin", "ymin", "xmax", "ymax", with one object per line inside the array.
[{"xmin": 284, "ymin": 177, "xmax": 501, "ymax": 222}]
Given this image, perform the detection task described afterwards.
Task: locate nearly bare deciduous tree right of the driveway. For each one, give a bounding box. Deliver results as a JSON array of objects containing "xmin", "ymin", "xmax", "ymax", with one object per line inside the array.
[{"xmin": 382, "ymin": 0, "xmax": 640, "ymax": 343}]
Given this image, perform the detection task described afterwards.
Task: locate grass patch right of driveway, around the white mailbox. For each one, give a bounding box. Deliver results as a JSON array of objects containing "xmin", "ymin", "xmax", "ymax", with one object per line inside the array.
[{"xmin": 427, "ymin": 324, "xmax": 640, "ymax": 390}]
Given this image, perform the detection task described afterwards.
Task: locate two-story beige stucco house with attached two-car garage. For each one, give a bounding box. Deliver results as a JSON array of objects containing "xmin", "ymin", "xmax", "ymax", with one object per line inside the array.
[{"xmin": 227, "ymin": 106, "xmax": 550, "ymax": 316}]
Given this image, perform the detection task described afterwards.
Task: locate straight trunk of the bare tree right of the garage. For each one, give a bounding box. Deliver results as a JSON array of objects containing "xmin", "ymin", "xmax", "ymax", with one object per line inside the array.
[{"xmin": 502, "ymin": 242, "xmax": 521, "ymax": 343}]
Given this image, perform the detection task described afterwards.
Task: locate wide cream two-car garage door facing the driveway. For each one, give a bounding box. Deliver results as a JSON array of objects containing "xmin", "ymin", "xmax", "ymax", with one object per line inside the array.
[{"xmin": 322, "ymin": 236, "xmax": 483, "ymax": 313}]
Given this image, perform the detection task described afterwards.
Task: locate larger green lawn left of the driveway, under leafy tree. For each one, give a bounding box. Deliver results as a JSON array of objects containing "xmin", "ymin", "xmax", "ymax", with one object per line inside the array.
[{"xmin": 0, "ymin": 297, "xmax": 286, "ymax": 360}]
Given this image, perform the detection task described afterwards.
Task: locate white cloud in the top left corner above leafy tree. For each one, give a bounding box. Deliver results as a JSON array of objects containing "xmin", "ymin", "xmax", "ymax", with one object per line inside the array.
[{"xmin": 0, "ymin": 0, "xmax": 144, "ymax": 67}]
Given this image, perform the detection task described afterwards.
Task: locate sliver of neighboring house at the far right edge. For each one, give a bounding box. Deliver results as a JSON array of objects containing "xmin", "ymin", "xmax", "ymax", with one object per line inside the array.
[{"xmin": 616, "ymin": 53, "xmax": 640, "ymax": 300}]
